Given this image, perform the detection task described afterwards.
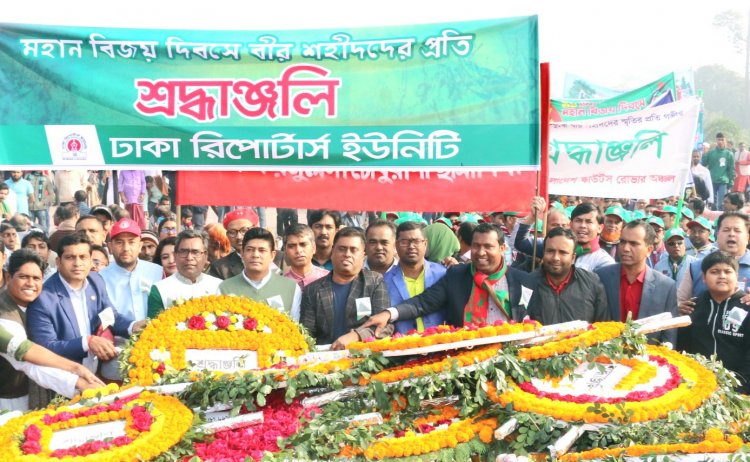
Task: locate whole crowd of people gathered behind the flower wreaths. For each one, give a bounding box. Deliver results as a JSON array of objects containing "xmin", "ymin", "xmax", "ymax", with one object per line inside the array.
[{"xmin": 0, "ymin": 134, "xmax": 750, "ymax": 409}]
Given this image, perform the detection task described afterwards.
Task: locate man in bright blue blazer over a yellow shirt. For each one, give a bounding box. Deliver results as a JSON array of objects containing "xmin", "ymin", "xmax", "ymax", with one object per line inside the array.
[{"xmin": 383, "ymin": 221, "xmax": 445, "ymax": 334}]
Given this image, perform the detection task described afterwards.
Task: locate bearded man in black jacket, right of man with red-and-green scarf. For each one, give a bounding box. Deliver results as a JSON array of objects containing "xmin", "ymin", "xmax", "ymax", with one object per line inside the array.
[{"xmin": 523, "ymin": 228, "xmax": 610, "ymax": 325}]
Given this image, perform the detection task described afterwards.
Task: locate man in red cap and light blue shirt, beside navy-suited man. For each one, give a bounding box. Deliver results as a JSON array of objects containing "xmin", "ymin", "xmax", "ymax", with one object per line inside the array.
[{"xmin": 99, "ymin": 218, "xmax": 162, "ymax": 380}]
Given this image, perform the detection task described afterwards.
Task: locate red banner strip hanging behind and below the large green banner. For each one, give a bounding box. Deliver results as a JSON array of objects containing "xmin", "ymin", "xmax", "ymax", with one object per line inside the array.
[{"xmin": 176, "ymin": 171, "xmax": 537, "ymax": 212}]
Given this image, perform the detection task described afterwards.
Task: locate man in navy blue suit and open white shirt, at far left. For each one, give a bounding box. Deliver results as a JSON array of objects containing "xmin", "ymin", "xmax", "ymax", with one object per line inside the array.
[{"xmin": 26, "ymin": 233, "xmax": 146, "ymax": 371}]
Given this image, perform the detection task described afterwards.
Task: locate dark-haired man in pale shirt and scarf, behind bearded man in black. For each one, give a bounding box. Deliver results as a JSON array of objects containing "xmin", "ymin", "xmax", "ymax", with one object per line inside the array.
[{"xmin": 570, "ymin": 202, "xmax": 615, "ymax": 271}]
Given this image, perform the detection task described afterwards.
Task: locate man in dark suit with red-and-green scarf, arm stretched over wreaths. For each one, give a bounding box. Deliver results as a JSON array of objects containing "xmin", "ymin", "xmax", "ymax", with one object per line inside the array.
[{"xmin": 363, "ymin": 223, "xmax": 525, "ymax": 328}]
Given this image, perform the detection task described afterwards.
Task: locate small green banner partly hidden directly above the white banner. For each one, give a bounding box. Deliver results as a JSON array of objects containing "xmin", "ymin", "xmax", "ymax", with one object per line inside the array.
[{"xmin": 550, "ymin": 73, "xmax": 679, "ymax": 122}]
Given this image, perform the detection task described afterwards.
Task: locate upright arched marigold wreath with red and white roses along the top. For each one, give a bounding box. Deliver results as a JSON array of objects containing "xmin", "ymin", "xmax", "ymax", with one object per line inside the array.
[{"xmin": 124, "ymin": 295, "xmax": 308, "ymax": 385}]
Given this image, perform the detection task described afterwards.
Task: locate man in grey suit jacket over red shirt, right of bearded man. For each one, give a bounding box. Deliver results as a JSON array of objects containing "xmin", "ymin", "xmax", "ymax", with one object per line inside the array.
[{"xmin": 596, "ymin": 221, "xmax": 677, "ymax": 344}]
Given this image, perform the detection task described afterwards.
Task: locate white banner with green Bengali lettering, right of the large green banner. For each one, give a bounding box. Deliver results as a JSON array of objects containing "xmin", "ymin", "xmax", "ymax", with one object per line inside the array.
[{"xmin": 549, "ymin": 98, "xmax": 700, "ymax": 199}]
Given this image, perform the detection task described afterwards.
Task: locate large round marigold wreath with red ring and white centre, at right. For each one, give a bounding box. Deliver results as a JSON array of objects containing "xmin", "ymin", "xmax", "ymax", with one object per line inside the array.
[{"xmin": 487, "ymin": 346, "xmax": 718, "ymax": 423}]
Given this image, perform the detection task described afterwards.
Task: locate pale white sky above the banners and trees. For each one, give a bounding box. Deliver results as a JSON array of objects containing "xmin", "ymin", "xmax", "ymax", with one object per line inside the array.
[{"xmin": 0, "ymin": 0, "xmax": 750, "ymax": 96}]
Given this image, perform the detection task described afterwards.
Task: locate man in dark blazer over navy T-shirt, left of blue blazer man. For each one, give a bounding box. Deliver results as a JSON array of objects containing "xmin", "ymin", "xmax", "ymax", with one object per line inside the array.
[{"xmin": 300, "ymin": 227, "xmax": 392, "ymax": 349}]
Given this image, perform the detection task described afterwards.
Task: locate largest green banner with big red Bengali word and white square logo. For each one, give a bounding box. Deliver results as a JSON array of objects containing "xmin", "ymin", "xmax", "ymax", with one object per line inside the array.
[{"xmin": 0, "ymin": 17, "xmax": 539, "ymax": 170}]
